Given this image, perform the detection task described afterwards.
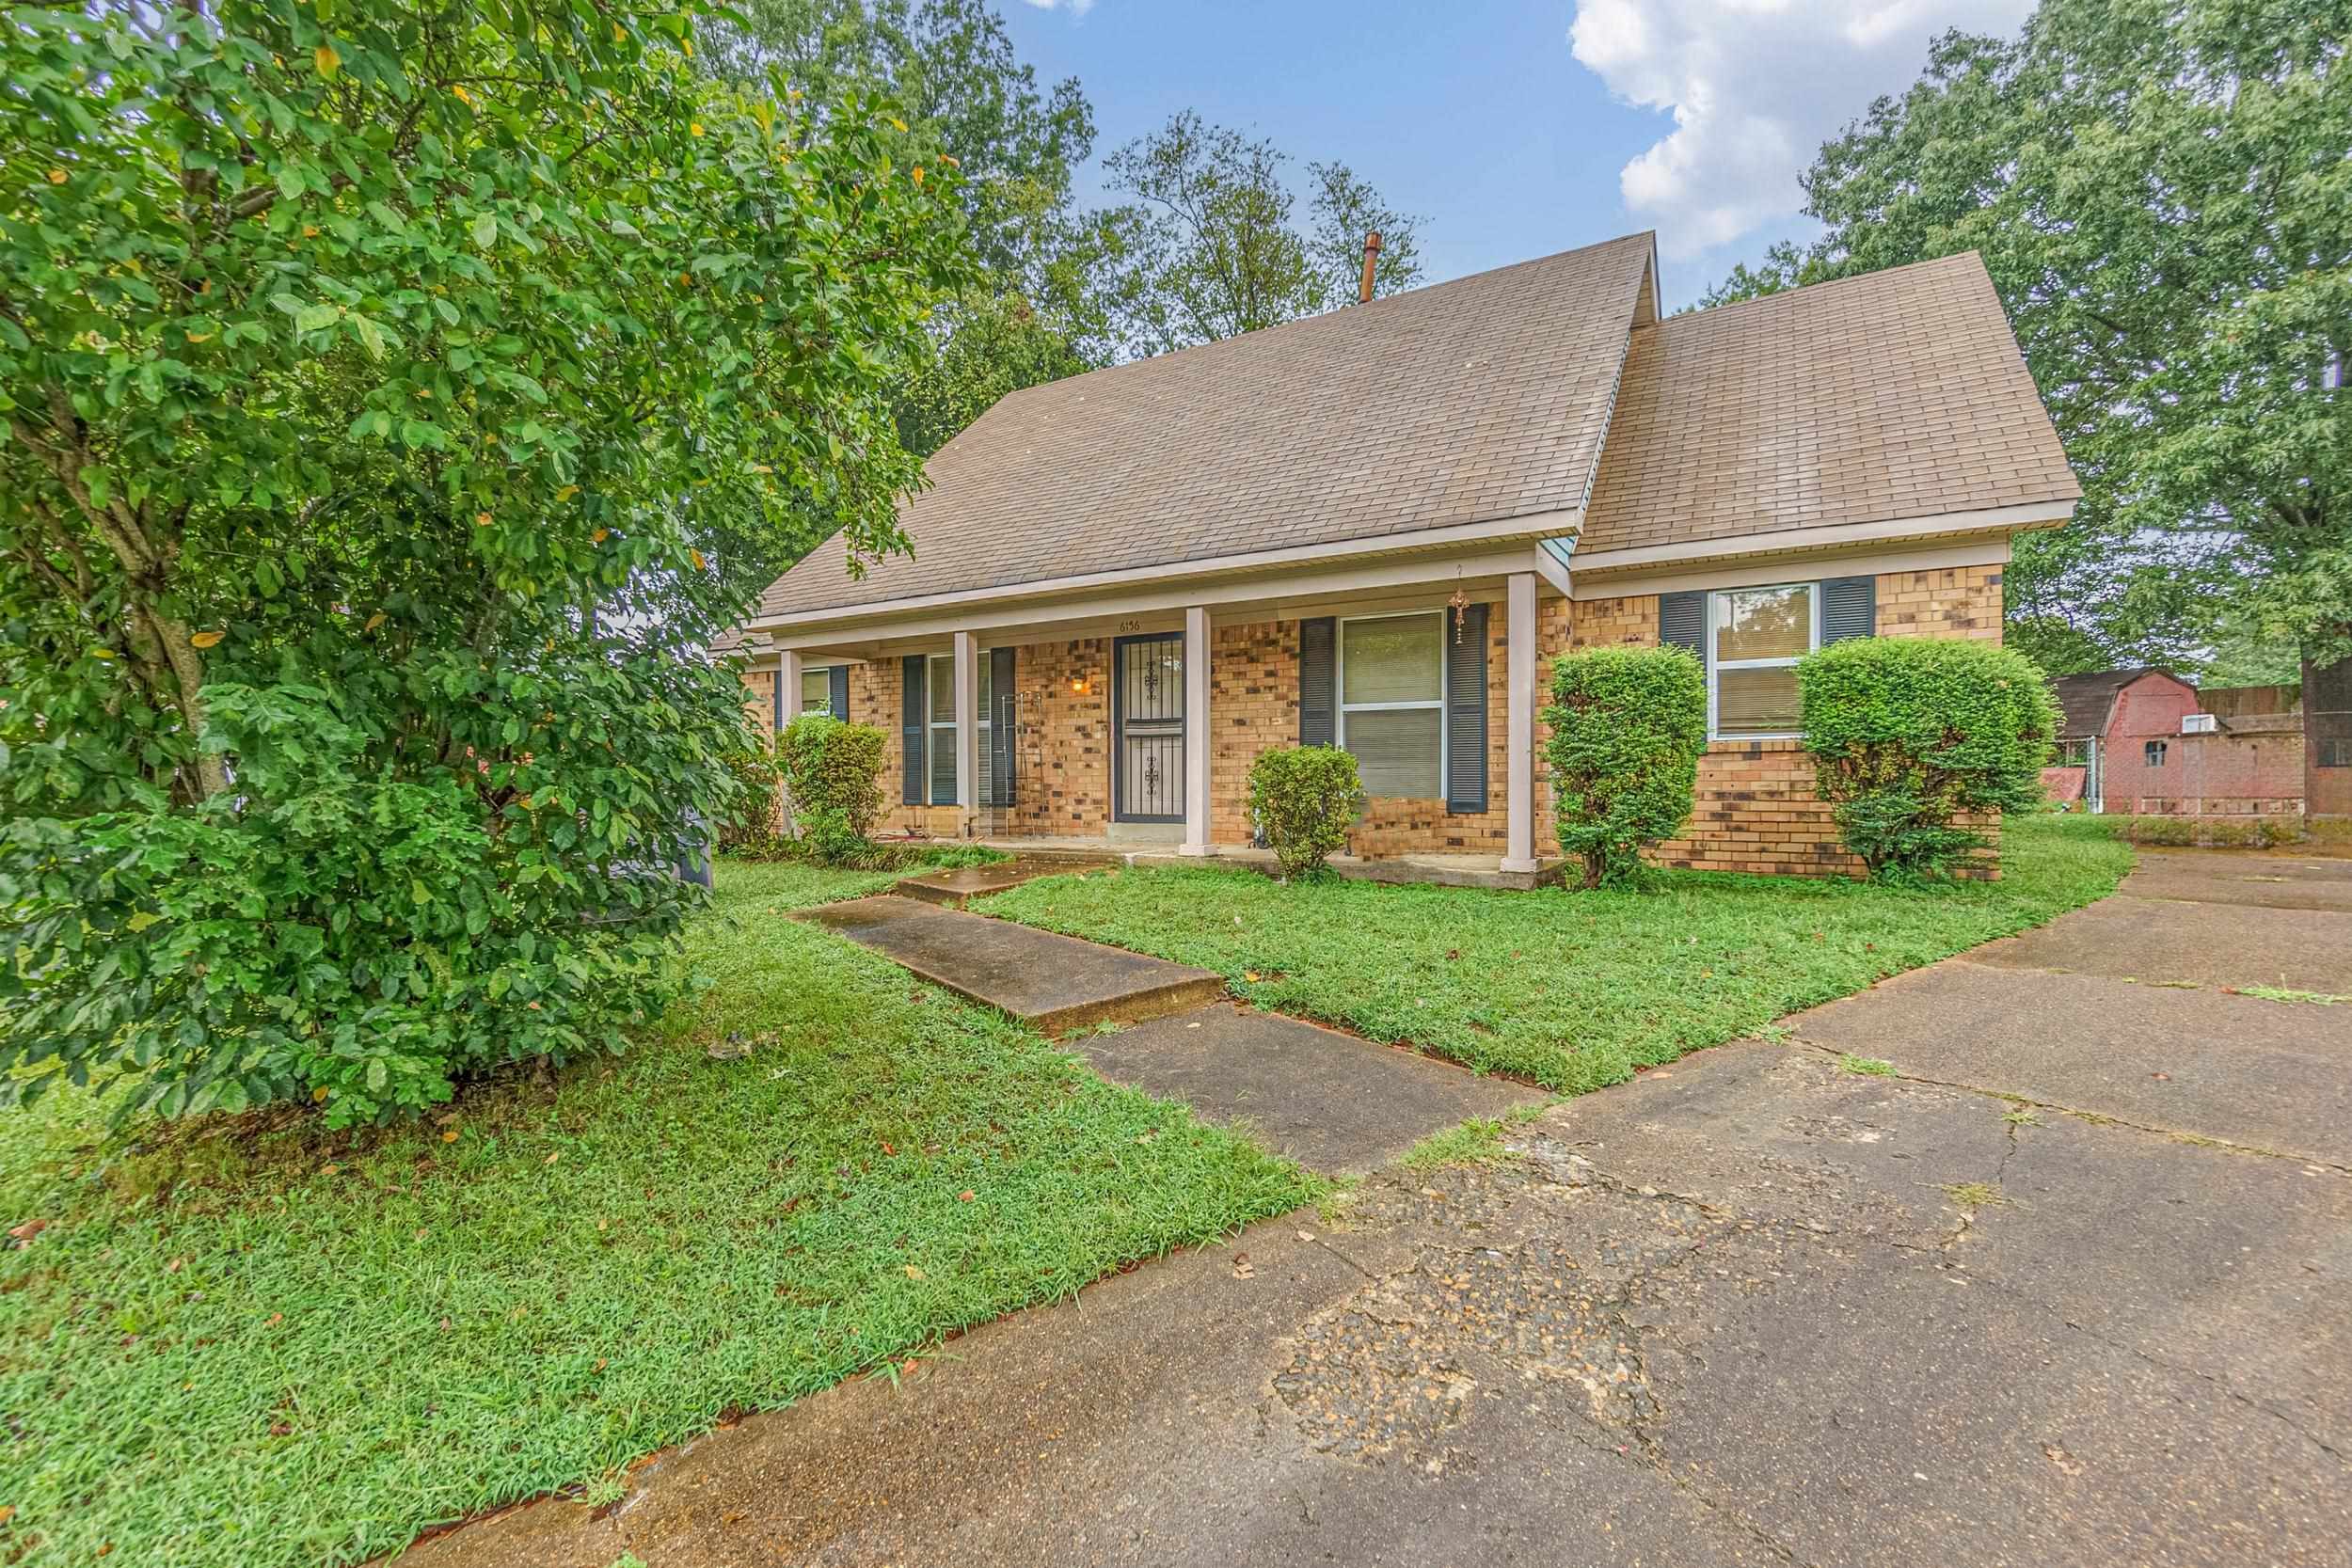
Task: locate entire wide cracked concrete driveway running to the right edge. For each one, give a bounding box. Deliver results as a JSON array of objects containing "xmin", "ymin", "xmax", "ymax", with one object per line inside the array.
[{"xmin": 407, "ymin": 856, "xmax": 2352, "ymax": 1568}]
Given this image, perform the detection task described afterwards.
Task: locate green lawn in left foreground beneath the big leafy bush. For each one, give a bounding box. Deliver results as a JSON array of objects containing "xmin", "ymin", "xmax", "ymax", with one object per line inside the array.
[{"xmin": 0, "ymin": 865, "xmax": 1320, "ymax": 1568}]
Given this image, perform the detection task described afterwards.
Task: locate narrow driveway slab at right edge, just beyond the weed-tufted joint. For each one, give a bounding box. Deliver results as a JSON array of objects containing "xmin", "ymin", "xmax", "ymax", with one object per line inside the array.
[{"xmin": 1969, "ymin": 894, "xmax": 2352, "ymax": 994}]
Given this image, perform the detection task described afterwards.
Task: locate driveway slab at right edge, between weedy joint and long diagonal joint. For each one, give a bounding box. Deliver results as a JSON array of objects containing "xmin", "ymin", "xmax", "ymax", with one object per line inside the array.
[{"xmin": 1783, "ymin": 961, "xmax": 2352, "ymax": 1166}]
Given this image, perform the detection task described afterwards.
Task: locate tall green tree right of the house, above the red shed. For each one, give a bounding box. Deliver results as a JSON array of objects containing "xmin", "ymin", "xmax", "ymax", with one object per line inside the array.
[{"xmin": 1710, "ymin": 0, "xmax": 2352, "ymax": 670}]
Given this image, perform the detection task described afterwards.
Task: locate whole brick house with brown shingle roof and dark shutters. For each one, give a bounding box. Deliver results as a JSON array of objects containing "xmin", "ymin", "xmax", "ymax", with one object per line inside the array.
[{"xmin": 737, "ymin": 235, "xmax": 2079, "ymax": 877}]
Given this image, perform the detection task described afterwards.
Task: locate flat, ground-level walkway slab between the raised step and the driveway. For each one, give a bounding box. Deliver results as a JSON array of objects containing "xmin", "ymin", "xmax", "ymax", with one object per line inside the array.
[{"xmin": 1077, "ymin": 1004, "xmax": 1543, "ymax": 1176}]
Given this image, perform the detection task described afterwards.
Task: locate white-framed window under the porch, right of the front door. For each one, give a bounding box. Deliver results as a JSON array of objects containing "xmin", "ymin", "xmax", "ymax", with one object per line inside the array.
[{"xmin": 1339, "ymin": 611, "xmax": 1447, "ymax": 800}]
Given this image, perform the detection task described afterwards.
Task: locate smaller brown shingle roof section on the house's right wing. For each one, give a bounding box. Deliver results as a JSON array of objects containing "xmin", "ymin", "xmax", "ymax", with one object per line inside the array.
[{"xmin": 1576, "ymin": 251, "xmax": 2082, "ymax": 555}]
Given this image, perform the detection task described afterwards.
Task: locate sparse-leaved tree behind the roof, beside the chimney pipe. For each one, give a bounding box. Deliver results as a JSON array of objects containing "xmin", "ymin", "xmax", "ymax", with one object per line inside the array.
[{"xmin": 1094, "ymin": 110, "xmax": 1421, "ymax": 353}]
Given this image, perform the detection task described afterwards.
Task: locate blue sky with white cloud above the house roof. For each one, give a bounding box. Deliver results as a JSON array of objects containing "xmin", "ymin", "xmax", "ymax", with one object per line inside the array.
[{"xmin": 997, "ymin": 0, "xmax": 2030, "ymax": 308}]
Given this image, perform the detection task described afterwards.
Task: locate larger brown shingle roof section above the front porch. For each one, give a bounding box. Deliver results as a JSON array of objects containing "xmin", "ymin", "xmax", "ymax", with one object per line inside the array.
[{"xmin": 760, "ymin": 232, "xmax": 1651, "ymax": 618}]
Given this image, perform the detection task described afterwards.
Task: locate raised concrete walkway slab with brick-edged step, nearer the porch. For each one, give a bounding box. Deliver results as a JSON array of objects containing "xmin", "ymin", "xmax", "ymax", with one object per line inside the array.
[{"xmin": 793, "ymin": 894, "xmax": 1226, "ymax": 1035}]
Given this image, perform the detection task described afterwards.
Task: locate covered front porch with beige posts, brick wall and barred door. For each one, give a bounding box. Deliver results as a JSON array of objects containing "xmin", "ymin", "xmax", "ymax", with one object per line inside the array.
[{"xmin": 755, "ymin": 546, "xmax": 1566, "ymax": 869}]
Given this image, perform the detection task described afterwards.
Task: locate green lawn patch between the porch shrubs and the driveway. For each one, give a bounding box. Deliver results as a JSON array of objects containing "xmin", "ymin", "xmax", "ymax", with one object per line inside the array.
[{"xmin": 977, "ymin": 816, "xmax": 2131, "ymax": 1093}]
